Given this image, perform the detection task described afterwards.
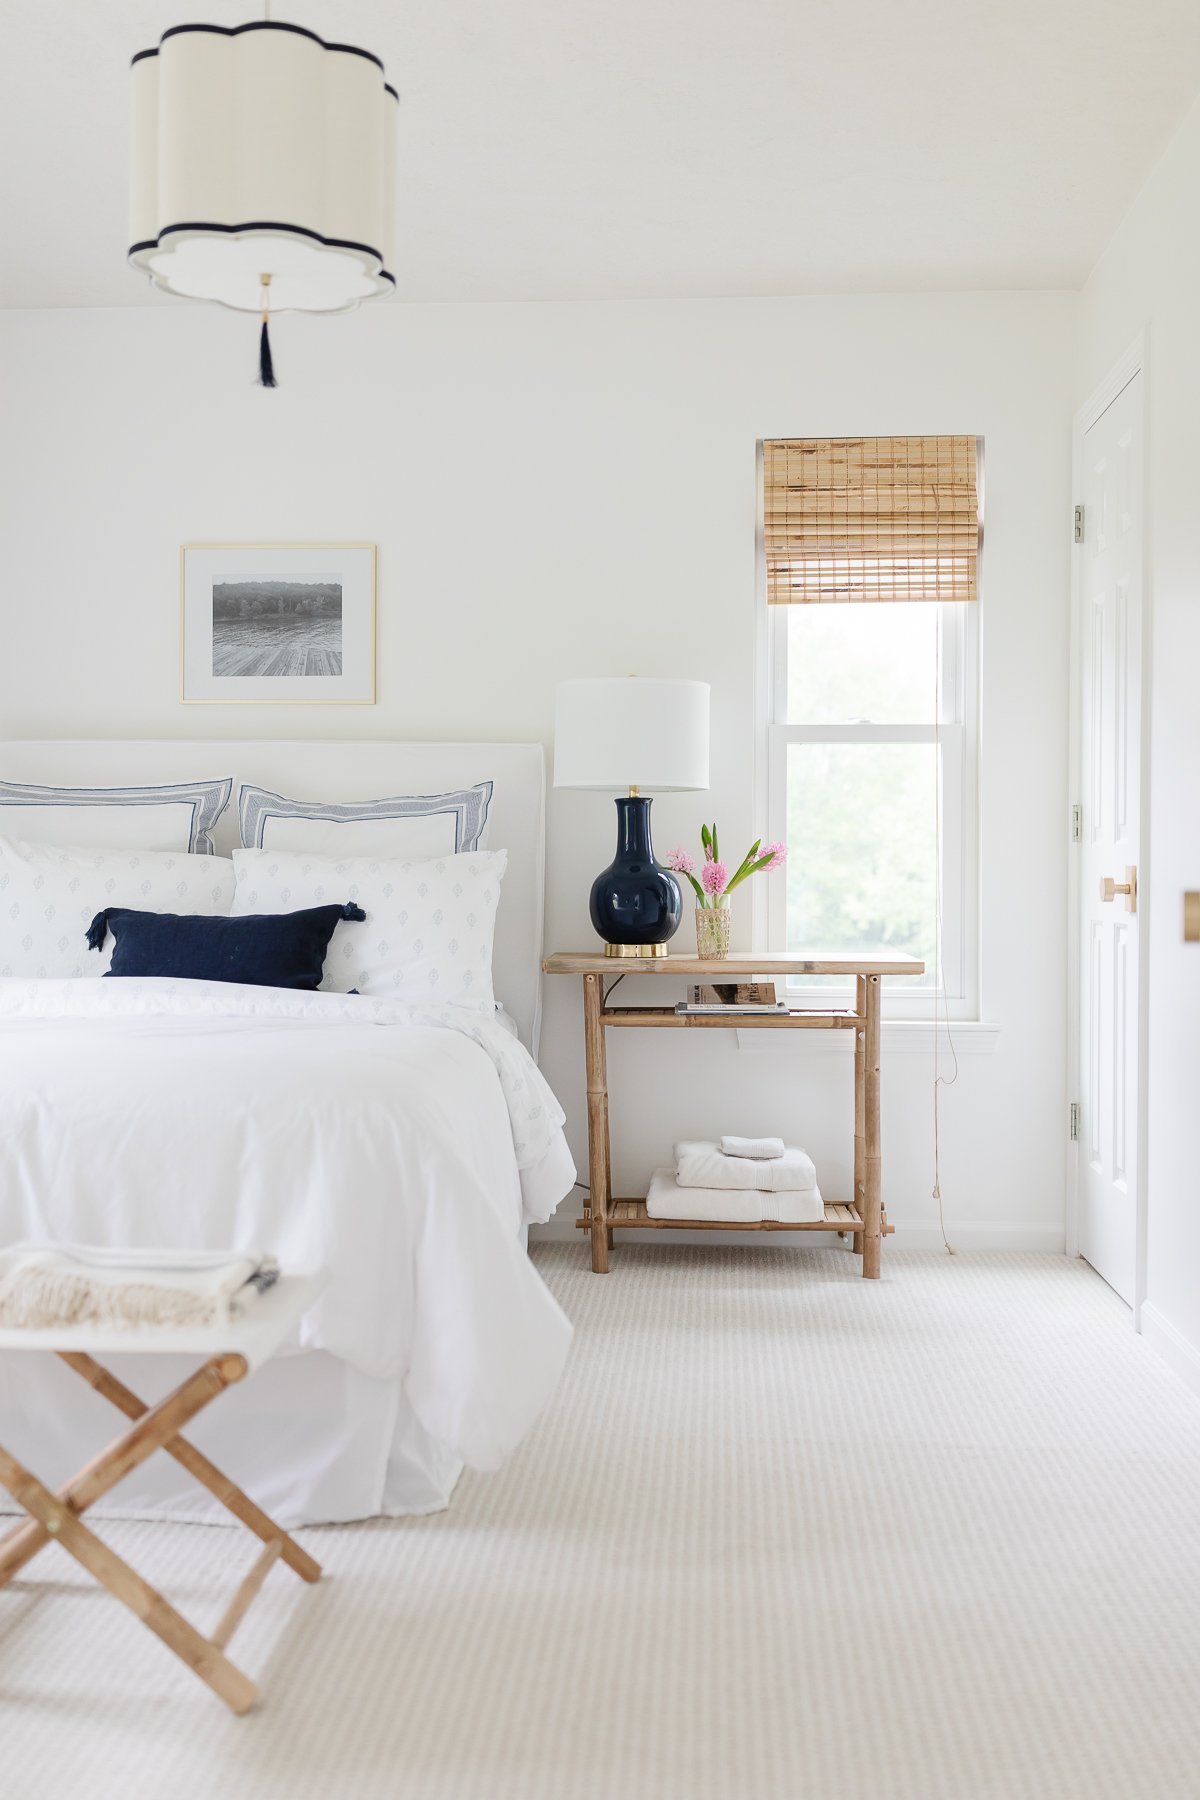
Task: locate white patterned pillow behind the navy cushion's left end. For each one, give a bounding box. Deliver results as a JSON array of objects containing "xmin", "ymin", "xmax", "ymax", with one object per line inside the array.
[{"xmin": 0, "ymin": 837, "xmax": 234, "ymax": 977}]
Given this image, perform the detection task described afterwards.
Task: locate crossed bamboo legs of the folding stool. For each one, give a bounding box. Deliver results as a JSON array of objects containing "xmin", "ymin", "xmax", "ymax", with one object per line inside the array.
[{"xmin": 0, "ymin": 1350, "xmax": 320, "ymax": 1714}]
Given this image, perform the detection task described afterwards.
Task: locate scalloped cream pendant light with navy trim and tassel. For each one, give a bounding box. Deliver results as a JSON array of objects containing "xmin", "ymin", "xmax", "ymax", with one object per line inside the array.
[{"xmin": 130, "ymin": 18, "xmax": 398, "ymax": 385}]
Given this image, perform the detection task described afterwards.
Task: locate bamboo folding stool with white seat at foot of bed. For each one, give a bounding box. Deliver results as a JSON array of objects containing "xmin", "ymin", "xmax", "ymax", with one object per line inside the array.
[{"xmin": 0, "ymin": 1274, "xmax": 326, "ymax": 1714}]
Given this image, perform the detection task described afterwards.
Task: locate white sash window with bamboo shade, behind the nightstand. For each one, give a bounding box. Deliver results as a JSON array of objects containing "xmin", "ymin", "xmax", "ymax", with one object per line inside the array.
[{"xmin": 761, "ymin": 439, "xmax": 979, "ymax": 1017}]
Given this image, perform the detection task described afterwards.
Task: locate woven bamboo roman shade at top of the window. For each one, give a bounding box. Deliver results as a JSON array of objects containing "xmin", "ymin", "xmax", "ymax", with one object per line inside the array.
[{"xmin": 763, "ymin": 437, "xmax": 979, "ymax": 607}]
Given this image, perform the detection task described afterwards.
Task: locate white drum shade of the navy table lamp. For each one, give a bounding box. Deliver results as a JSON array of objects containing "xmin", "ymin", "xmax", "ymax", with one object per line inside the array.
[{"xmin": 554, "ymin": 675, "xmax": 709, "ymax": 794}]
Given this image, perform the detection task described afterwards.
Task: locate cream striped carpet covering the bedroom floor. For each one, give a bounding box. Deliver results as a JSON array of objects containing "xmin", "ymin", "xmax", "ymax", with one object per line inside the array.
[{"xmin": 0, "ymin": 1244, "xmax": 1200, "ymax": 1800}]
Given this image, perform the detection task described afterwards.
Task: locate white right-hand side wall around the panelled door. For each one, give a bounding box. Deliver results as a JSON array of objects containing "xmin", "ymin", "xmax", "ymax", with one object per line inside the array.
[{"xmin": 1078, "ymin": 91, "xmax": 1200, "ymax": 1382}]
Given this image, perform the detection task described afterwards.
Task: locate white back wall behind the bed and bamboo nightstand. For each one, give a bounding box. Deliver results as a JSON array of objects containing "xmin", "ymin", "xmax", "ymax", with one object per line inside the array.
[{"xmin": 0, "ymin": 293, "xmax": 1076, "ymax": 1247}]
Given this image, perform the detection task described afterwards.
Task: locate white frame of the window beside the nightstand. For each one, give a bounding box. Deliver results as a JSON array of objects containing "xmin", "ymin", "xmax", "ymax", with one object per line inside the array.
[{"xmin": 752, "ymin": 478, "xmax": 979, "ymax": 1019}]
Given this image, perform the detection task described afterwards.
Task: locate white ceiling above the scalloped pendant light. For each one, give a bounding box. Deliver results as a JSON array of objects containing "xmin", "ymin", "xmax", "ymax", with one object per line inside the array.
[{"xmin": 0, "ymin": 0, "xmax": 1200, "ymax": 306}]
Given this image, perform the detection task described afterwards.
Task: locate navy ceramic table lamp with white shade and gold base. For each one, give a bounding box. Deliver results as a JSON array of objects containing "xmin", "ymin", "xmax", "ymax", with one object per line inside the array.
[{"xmin": 554, "ymin": 675, "xmax": 709, "ymax": 956}]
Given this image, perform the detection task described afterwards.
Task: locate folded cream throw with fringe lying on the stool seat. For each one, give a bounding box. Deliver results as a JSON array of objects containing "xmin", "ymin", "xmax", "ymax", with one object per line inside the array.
[{"xmin": 0, "ymin": 1244, "xmax": 279, "ymax": 1330}]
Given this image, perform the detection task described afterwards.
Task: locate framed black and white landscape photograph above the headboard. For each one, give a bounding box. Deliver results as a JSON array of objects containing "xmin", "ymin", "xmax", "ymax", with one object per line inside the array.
[{"xmin": 180, "ymin": 544, "xmax": 376, "ymax": 706}]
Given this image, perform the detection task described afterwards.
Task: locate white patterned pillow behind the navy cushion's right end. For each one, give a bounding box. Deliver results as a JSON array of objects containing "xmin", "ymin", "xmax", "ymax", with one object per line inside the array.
[{"xmin": 234, "ymin": 850, "xmax": 507, "ymax": 1015}]
